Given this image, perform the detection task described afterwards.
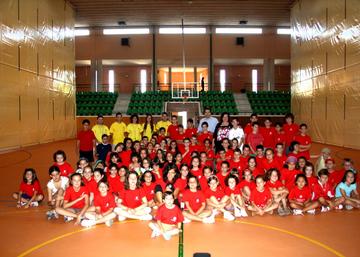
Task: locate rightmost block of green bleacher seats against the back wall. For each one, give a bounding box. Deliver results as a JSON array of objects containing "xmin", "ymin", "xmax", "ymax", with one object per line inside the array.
[{"xmin": 247, "ymin": 91, "xmax": 291, "ymax": 115}]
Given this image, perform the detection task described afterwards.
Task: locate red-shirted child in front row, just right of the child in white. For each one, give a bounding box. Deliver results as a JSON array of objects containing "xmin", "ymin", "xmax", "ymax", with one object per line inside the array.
[{"xmin": 55, "ymin": 173, "xmax": 89, "ymax": 225}]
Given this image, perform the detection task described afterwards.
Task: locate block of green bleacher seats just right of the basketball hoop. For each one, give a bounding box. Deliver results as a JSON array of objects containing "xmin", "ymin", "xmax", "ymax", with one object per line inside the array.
[{"xmin": 200, "ymin": 91, "xmax": 238, "ymax": 114}]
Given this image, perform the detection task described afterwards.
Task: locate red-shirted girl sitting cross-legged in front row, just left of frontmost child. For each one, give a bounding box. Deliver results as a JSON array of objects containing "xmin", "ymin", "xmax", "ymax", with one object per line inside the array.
[{"xmin": 114, "ymin": 171, "xmax": 152, "ymax": 221}]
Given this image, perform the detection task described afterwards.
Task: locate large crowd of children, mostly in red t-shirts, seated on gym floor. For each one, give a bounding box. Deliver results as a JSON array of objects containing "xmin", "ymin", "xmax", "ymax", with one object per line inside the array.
[{"xmin": 14, "ymin": 111, "xmax": 360, "ymax": 239}]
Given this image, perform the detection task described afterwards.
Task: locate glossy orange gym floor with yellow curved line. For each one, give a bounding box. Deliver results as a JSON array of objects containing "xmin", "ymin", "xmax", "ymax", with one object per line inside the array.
[{"xmin": 0, "ymin": 140, "xmax": 360, "ymax": 257}]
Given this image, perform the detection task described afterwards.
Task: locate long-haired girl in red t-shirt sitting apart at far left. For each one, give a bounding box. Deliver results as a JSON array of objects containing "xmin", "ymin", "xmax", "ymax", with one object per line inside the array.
[{"xmin": 13, "ymin": 168, "xmax": 44, "ymax": 208}]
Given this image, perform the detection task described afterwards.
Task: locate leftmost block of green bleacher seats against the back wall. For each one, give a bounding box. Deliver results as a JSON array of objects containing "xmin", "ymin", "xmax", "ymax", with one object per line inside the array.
[{"xmin": 76, "ymin": 92, "xmax": 118, "ymax": 116}]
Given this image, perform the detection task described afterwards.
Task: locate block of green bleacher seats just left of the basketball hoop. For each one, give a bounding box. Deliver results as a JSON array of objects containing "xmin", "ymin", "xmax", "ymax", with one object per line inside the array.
[{"xmin": 127, "ymin": 91, "xmax": 171, "ymax": 115}]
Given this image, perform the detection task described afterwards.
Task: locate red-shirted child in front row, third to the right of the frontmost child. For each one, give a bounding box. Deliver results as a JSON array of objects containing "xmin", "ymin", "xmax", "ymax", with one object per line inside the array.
[{"xmin": 225, "ymin": 174, "xmax": 248, "ymax": 217}]
